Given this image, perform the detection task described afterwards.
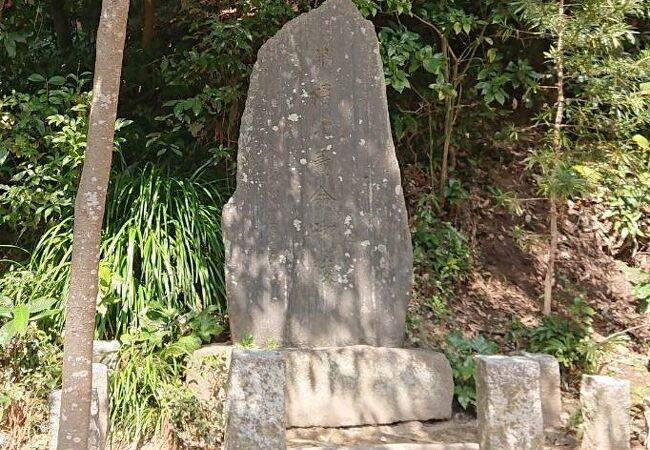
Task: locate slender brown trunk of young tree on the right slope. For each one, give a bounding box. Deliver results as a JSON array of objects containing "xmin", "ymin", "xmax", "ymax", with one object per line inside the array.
[{"xmin": 542, "ymin": 0, "xmax": 565, "ymax": 315}]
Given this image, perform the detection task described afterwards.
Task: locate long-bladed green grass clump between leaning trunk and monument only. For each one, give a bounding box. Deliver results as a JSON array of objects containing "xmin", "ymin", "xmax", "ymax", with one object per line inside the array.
[{"xmin": 97, "ymin": 164, "xmax": 225, "ymax": 338}]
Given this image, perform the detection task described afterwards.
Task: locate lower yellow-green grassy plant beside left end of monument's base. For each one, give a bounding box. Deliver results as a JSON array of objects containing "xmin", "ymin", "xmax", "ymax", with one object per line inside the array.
[{"xmin": 110, "ymin": 302, "xmax": 223, "ymax": 439}]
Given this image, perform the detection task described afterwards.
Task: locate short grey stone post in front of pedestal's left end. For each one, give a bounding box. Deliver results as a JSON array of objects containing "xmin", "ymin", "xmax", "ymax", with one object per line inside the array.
[{"xmin": 225, "ymin": 349, "xmax": 286, "ymax": 450}]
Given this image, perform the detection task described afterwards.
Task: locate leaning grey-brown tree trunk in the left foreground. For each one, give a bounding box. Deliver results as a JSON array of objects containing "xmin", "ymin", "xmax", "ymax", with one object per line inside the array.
[{"xmin": 57, "ymin": 0, "xmax": 129, "ymax": 450}]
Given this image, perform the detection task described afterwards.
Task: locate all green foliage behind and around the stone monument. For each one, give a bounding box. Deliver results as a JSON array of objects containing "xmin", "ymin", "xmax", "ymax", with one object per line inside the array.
[{"xmin": 0, "ymin": 0, "xmax": 650, "ymax": 445}]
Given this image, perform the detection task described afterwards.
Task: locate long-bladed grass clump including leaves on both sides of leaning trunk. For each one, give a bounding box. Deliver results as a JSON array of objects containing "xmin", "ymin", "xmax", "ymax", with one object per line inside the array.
[{"xmin": 0, "ymin": 165, "xmax": 225, "ymax": 339}]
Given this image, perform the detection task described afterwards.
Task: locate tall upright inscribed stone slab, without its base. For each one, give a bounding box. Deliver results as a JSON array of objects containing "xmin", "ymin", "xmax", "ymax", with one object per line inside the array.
[{"xmin": 223, "ymin": 0, "xmax": 412, "ymax": 347}]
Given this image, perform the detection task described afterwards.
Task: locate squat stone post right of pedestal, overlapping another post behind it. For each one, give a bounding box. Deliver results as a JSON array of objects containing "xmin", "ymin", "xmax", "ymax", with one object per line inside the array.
[{"xmin": 475, "ymin": 356, "xmax": 544, "ymax": 450}]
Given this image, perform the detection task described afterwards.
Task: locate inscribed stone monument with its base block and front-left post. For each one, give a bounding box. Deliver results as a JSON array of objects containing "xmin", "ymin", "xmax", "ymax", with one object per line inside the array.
[{"xmin": 223, "ymin": 0, "xmax": 454, "ymax": 450}]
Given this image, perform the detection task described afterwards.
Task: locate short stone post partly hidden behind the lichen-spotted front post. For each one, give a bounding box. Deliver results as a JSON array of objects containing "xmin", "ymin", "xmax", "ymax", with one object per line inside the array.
[{"xmin": 523, "ymin": 353, "xmax": 562, "ymax": 428}]
